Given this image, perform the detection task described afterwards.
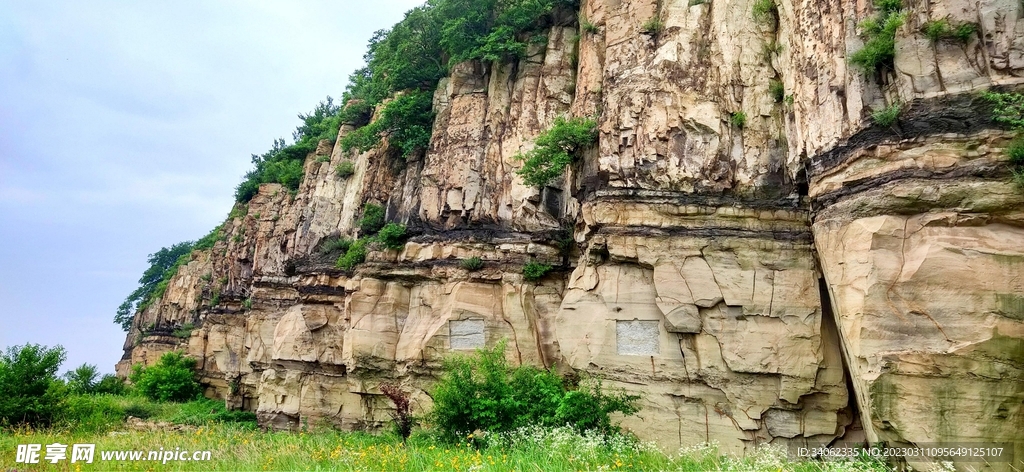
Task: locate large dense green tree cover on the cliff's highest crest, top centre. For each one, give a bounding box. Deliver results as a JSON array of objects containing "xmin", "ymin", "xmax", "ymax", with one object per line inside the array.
[{"xmin": 340, "ymin": 0, "xmax": 579, "ymax": 158}]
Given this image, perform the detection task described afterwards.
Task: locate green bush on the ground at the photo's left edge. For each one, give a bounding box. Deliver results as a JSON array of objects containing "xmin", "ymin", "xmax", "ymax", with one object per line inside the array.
[{"xmin": 0, "ymin": 344, "xmax": 67, "ymax": 426}]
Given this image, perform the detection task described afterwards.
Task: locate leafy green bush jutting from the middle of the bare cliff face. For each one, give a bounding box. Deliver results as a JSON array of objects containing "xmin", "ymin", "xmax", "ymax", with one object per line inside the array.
[{"xmin": 515, "ymin": 117, "xmax": 597, "ymax": 186}]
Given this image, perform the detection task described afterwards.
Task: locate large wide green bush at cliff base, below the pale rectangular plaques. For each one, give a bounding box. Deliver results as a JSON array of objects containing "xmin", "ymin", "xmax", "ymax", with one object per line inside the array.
[{"xmin": 431, "ymin": 341, "xmax": 639, "ymax": 439}]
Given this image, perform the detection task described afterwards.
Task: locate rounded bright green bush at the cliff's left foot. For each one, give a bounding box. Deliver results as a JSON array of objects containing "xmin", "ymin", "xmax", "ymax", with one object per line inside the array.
[{"xmin": 130, "ymin": 351, "xmax": 202, "ymax": 401}]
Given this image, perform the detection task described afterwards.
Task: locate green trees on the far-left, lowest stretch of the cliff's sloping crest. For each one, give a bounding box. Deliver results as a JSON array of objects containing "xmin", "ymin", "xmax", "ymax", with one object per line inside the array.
[{"xmin": 114, "ymin": 237, "xmax": 195, "ymax": 331}]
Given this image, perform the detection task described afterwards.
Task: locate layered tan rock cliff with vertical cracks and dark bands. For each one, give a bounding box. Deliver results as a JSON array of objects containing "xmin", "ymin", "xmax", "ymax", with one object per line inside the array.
[{"xmin": 119, "ymin": 0, "xmax": 1024, "ymax": 469}]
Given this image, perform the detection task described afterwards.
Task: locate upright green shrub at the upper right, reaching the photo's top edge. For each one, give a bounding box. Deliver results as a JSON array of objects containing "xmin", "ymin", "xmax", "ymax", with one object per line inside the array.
[{"xmin": 850, "ymin": 0, "xmax": 906, "ymax": 74}]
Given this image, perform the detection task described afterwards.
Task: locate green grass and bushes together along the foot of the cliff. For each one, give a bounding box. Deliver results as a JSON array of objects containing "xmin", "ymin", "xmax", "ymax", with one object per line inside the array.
[{"xmin": 0, "ymin": 337, "xmax": 889, "ymax": 472}]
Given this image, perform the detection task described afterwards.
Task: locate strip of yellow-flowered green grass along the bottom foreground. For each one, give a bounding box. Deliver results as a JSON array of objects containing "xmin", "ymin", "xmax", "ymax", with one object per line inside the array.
[{"xmin": 0, "ymin": 424, "xmax": 889, "ymax": 472}]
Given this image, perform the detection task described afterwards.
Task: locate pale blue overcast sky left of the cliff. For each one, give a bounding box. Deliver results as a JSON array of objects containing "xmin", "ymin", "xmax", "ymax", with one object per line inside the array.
[{"xmin": 0, "ymin": 0, "xmax": 422, "ymax": 373}]
